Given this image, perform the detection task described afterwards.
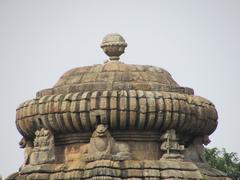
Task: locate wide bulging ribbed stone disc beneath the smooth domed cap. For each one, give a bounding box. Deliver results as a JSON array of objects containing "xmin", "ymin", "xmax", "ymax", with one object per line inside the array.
[{"xmin": 16, "ymin": 90, "xmax": 217, "ymax": 137}]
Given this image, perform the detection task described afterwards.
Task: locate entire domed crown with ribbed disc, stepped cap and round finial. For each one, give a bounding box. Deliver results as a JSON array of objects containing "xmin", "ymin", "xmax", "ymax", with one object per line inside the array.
[{"xmin": 16, "ymin": 34, "xmax": 217, "ymax": 142}]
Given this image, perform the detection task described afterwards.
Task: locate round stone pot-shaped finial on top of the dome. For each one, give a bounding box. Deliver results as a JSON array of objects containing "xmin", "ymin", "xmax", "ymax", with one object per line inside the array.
[{"xmin": 101, "ymin": 33, "xmax": 127, "ymax": 61}]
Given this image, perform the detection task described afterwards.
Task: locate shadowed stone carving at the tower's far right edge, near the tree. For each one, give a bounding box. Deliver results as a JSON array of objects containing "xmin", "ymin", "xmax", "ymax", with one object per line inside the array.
[{"xmin": 184, "ymin": 135, "xmax": 211, "ymax": 163}]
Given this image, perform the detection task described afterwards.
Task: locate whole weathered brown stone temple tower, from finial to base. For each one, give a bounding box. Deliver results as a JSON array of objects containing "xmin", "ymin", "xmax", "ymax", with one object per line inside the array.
[{"xmin": 8, "ymin": 34, "xmax": 228, "ymax": 180}]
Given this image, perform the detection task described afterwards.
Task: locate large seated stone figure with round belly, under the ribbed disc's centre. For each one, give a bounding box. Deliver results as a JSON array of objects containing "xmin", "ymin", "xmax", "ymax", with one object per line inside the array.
[{"xmin": 81, "ymin": 124, "xmax": 131, "ymax": 162}]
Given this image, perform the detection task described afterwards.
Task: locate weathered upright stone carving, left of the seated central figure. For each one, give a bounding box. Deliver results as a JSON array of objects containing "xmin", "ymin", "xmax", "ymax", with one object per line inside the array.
[{"xmin": 30, "ymin": 128, "xmax": 55, "ymax": 165}]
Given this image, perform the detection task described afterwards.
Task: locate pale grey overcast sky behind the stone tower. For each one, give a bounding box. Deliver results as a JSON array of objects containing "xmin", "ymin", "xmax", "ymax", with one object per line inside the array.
[{"xmin": 0, "ymin": 0, "xmax": 240, "ymax": 177}]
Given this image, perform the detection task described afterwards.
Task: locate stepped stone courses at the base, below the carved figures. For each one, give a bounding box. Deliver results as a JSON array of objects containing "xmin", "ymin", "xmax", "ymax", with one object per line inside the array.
[{"xmin": 15, "ymin": 160, "xmax": 205, "ymax": 180}]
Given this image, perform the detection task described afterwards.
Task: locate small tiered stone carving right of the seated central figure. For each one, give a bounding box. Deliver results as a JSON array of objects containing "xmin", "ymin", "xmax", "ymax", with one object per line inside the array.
[{"xmin": 161, "ymin": 129, "xmax": 184, "ymax": 159}]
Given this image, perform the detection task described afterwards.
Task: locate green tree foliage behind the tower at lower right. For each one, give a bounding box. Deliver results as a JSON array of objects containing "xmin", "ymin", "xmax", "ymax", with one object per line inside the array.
[{"xmin": 206, "ymin": 148, "xmax": 240, "ymax": 180}]
